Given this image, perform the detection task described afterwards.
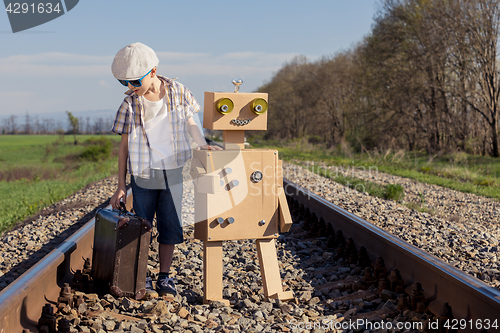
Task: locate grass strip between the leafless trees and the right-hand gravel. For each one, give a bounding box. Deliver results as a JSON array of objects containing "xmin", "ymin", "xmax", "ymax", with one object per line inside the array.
[{"xmin": 250, "ymin": 140, "xmax": 500, "ymax": 200}]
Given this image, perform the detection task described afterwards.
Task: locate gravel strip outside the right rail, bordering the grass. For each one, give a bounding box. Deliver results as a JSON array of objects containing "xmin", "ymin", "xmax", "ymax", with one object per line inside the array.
[{"xmin": 284, "ymin": 164, "xmax": 500, "ymax": 288}]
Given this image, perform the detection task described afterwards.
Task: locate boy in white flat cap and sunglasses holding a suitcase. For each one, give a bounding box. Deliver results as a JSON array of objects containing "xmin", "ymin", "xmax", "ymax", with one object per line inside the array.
[{"xmin": 111, "ymin": 43, "xmax": 220, "ymax": 295}]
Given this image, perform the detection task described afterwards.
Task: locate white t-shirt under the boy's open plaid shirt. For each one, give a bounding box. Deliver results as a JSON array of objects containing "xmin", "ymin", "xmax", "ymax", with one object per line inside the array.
[{"xmin": 144, "ymin": 98, "xmax": 178, "ymax": 170}]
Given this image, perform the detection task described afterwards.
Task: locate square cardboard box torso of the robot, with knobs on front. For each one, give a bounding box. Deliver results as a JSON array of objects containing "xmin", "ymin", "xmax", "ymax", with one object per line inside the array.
[{"xmin": 191, "ymin": 149, "xmax": 283, "ymax": 242}]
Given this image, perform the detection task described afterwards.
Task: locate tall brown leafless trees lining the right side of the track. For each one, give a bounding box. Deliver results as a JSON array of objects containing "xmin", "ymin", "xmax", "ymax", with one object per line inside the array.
[{"xmin": 259, "ymin": 0, "xmax": 500, "ymax": 157}]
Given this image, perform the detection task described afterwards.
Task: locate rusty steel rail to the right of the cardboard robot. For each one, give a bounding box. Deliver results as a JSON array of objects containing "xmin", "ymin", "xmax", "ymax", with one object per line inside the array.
[{"xmin": 284, "ymin": 179, "xmax": 500, "ymax": 332}]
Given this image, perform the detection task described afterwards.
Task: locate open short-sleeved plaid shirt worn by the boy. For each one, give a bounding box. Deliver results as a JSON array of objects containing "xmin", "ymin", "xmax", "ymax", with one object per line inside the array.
[{"xmin": 111, "ymin": 75, "xmax": 201, "ymax": 179}]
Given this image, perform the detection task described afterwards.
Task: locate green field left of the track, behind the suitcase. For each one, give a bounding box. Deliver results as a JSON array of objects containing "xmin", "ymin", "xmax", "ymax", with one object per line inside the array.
[{"xmin": 0, "ymin": 135, "xmax": 120, "ymax": 232}]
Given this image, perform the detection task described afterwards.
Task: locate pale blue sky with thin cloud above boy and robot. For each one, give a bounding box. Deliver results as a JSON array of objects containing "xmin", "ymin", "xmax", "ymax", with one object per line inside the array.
[{"xmin": 0, "ymin": 0, "xmax": 379, "ymax": 126}]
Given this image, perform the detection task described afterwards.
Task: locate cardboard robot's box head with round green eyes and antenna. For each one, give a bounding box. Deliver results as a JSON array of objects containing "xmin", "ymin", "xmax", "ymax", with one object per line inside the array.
[{"xmin": 203, "ymin": 80, "xmax": 268, "ymax": 131}]
